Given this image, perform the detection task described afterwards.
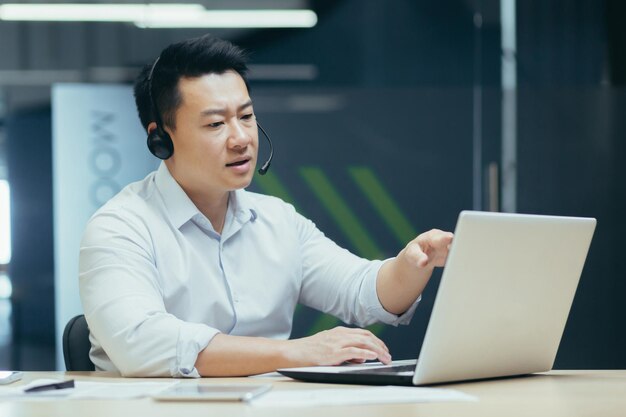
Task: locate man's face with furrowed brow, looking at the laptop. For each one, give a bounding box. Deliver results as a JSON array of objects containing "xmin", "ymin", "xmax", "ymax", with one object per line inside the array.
[{"xmin": 166, "ymin": 71, "xmax": 258, "ymax": 199}]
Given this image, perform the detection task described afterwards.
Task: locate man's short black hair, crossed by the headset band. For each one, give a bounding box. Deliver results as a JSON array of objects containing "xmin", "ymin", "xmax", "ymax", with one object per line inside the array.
[{"xmin": 134, "ymin": 34, "xmax": 249, "ymax": 130}]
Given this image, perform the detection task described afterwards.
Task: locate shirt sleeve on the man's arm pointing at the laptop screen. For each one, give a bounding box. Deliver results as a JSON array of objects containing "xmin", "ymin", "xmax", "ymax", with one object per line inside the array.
[{"xmin": 294, "ymin": 207, "xmax": 419, "ymax": 327}]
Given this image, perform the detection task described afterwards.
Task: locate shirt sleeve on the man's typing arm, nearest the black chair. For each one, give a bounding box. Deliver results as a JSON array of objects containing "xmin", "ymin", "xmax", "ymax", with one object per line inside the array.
[{"xmin": 79, "ymin": 208, "xmax": 219, "ymax": 377}]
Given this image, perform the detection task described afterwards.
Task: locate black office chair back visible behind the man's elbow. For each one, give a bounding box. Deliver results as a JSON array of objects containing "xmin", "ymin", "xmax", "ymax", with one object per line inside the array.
[{"xmin": 63, "ymin": 314, "xmax": 96, "ymax": 371}]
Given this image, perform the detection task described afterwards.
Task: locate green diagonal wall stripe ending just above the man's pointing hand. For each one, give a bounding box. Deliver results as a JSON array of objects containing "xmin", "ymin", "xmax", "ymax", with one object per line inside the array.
[{"xmin": 348, "ymin": 167, "xmax": 417, "ymax": 245}]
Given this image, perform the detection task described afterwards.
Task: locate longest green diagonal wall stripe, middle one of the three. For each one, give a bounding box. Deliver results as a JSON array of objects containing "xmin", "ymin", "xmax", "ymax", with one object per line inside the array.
[{"xmin": 300, "ymin": 167, "xmax": 382, "ymax": 259}]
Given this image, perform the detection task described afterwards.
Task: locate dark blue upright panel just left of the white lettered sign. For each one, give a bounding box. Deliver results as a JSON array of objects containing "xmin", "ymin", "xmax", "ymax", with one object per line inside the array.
[{"xmin": 6, "ymin": 107, "xmax": 54, "ymax": 370}]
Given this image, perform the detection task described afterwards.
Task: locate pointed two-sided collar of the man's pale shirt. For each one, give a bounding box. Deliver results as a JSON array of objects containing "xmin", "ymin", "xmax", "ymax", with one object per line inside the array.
[{"xmin": 155, "ymin": 162, "xmax": 257, "ymax": 229}]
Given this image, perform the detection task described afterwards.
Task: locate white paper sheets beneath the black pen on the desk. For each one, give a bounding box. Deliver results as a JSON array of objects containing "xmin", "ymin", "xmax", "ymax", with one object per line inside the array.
[{"xmin": 0, "ymin": 379, "xmax": 179, "ymax": 400}]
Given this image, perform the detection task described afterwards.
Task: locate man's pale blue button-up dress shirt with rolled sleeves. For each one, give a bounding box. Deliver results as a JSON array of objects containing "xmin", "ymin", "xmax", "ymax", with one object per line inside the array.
[{"xmin": 79, "ymin": 163, "xmax": 417, "ymax": 377}]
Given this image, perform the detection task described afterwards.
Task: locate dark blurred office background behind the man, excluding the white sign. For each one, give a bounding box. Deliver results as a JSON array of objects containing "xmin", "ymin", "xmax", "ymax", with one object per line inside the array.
[{"xmin": 0, "ymin": 0, "xmax": 626, "ymax": 370}]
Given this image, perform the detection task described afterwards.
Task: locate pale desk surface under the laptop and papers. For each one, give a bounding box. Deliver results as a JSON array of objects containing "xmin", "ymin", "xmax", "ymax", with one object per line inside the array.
[{"xmin": 0, "ymin": 370, "xmax": 626, "ymax": 417}]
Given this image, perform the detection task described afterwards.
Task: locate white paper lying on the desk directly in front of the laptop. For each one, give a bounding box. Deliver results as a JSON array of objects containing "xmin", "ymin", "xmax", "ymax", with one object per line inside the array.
[{"xmin": 251, "ymin": 386, "xmax": 478, "ymax": 407}]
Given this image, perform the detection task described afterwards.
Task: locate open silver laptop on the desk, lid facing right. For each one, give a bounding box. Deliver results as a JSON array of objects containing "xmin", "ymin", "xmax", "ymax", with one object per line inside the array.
[{"xmin": 278, "ymin": 211, "xmax": 596, "ymax": 385}]
